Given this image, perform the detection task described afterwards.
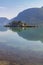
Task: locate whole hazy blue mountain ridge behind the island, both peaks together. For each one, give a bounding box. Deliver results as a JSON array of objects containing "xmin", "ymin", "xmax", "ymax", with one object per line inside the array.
[{"xmin": 0, "ymin": 7, "xmax": 43, "ymax": 26}]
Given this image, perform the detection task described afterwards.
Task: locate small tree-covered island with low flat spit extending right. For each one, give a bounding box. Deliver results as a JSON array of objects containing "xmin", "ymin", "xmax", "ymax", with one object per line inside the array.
[{"xmin": 5, "ymin": 21, "xmax": 36, "ymax": 27}]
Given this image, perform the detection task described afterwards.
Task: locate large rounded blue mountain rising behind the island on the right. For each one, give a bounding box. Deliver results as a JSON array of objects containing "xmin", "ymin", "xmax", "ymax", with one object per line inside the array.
[{"xmin": 10, "ymin": 7, "xmax": 43, "ymax": 25}]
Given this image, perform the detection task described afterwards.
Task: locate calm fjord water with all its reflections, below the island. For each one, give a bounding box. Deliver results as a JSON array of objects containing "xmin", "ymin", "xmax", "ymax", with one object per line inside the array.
[{"xmin": 0, "ymin": 27, "xmax": 43, "ymax": 65}]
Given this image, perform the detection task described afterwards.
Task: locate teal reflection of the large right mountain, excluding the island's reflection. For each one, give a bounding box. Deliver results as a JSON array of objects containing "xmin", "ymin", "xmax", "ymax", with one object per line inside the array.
[{"xmin": 9, "ymin": 27, "xmax": 43, "ymax": 41}]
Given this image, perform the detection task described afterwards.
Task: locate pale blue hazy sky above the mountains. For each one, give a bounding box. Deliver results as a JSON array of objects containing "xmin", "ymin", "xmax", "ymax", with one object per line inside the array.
[{"xmin": 0, "ymin": 0, "xmax": 43, "ymax": 18}]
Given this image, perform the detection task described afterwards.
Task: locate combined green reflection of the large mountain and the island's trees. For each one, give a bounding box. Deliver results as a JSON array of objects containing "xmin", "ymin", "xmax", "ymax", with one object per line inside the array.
[{"xmin": 10, "ymin": 27, "xmax": 43, "ymax": 42}]
